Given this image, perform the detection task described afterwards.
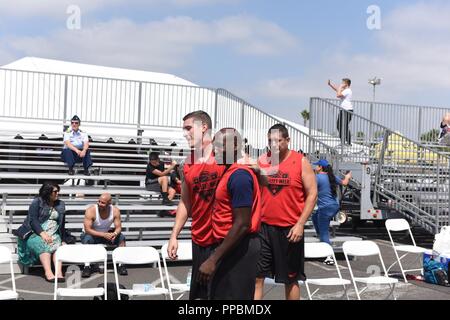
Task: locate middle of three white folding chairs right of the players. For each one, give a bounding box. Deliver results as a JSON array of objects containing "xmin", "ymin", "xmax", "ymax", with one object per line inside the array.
[{"xmin": 342, "ymin": 241, "xmax": 398, "ymax": 300}]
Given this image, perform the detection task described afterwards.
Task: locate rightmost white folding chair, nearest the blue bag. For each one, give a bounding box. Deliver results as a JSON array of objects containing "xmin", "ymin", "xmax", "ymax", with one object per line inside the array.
[{"xmin": 386, "ymin": 219, "xmax": 428, "ymax": 283}]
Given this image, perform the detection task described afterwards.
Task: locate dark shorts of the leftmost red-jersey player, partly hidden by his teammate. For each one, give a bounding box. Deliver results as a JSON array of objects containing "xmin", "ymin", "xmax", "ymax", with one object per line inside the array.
[{"xmin": 189, "ymin": 242, "xmax": 216, "ymax": 300}]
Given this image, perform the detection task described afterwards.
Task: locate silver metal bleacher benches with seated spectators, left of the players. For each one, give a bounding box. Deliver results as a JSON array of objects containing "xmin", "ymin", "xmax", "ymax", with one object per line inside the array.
[{"xmin": 0, "ymin": 132, "xmax": 190, "ymax": 272}]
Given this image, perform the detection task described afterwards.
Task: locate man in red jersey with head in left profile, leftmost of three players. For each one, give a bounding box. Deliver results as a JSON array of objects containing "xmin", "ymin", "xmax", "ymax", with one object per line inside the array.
[{"xmin": 167, "ymin": 111, "xmax": 225, "ymax": 300}]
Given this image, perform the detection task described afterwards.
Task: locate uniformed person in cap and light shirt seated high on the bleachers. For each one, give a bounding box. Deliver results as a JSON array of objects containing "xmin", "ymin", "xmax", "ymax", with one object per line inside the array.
[{"xmin": 61, "ymin": 116, "xmax": 92, "ymax": 176}]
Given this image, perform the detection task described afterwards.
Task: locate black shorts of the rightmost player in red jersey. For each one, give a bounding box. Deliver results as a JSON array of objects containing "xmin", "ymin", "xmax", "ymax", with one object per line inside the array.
[{"xmin": 257, "ymin": 223, "xmax": 306, "ymax": 284}]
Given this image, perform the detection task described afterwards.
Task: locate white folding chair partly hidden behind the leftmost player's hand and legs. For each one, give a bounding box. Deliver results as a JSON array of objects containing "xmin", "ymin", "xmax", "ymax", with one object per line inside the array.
[{"xmin": 161, "ymin": 241, "xmax": 192, "ymax": 300}]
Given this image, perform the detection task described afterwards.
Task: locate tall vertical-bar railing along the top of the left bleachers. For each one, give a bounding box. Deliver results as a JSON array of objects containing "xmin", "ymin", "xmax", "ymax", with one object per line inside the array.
[{"xmin": 0, "ymin": 69, "xmax": 216, "ymax": 128}]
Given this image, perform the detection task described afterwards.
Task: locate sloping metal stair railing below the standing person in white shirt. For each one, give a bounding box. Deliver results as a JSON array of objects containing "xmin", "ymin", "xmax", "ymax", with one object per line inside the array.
[{"xmin": 310, "ymin": 98, "xmax": 450, "ymax": 232}]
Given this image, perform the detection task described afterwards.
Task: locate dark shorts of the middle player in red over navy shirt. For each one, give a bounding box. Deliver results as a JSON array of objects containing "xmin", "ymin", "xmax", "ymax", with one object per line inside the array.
[{"xmin": 209, "ymin": 234, "xmax": 261, "ymax": 300}]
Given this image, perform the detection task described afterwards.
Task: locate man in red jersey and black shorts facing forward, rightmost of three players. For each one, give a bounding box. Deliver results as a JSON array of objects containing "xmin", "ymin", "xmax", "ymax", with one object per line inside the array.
[{"xmin": 255, "ymin": 124, "xmax": 317, "ymax": 300}]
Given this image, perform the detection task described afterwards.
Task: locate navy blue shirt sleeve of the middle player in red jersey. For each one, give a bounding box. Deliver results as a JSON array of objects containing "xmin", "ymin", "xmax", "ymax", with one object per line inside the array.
[{"xmin": 227, "ymin": 169, "xmax": 253, "ymax": 208}]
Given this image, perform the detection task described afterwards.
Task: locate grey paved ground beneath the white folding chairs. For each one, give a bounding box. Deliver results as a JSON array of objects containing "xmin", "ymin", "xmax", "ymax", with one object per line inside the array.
[{"xmin": 0, "ymin": 237, "xmax": 450, "ymax": 300}]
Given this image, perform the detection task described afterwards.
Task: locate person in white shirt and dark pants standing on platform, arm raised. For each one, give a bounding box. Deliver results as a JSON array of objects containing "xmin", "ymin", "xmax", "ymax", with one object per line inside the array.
[{"xmin": 328, "ymin": 78, "xmax": 353, "ymax": 146}]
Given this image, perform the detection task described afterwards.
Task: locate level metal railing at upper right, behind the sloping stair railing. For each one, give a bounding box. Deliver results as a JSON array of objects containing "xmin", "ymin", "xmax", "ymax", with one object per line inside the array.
[{"xmin": 326, "ymin": 99, "xmax": 450, "ymax": 143}]
